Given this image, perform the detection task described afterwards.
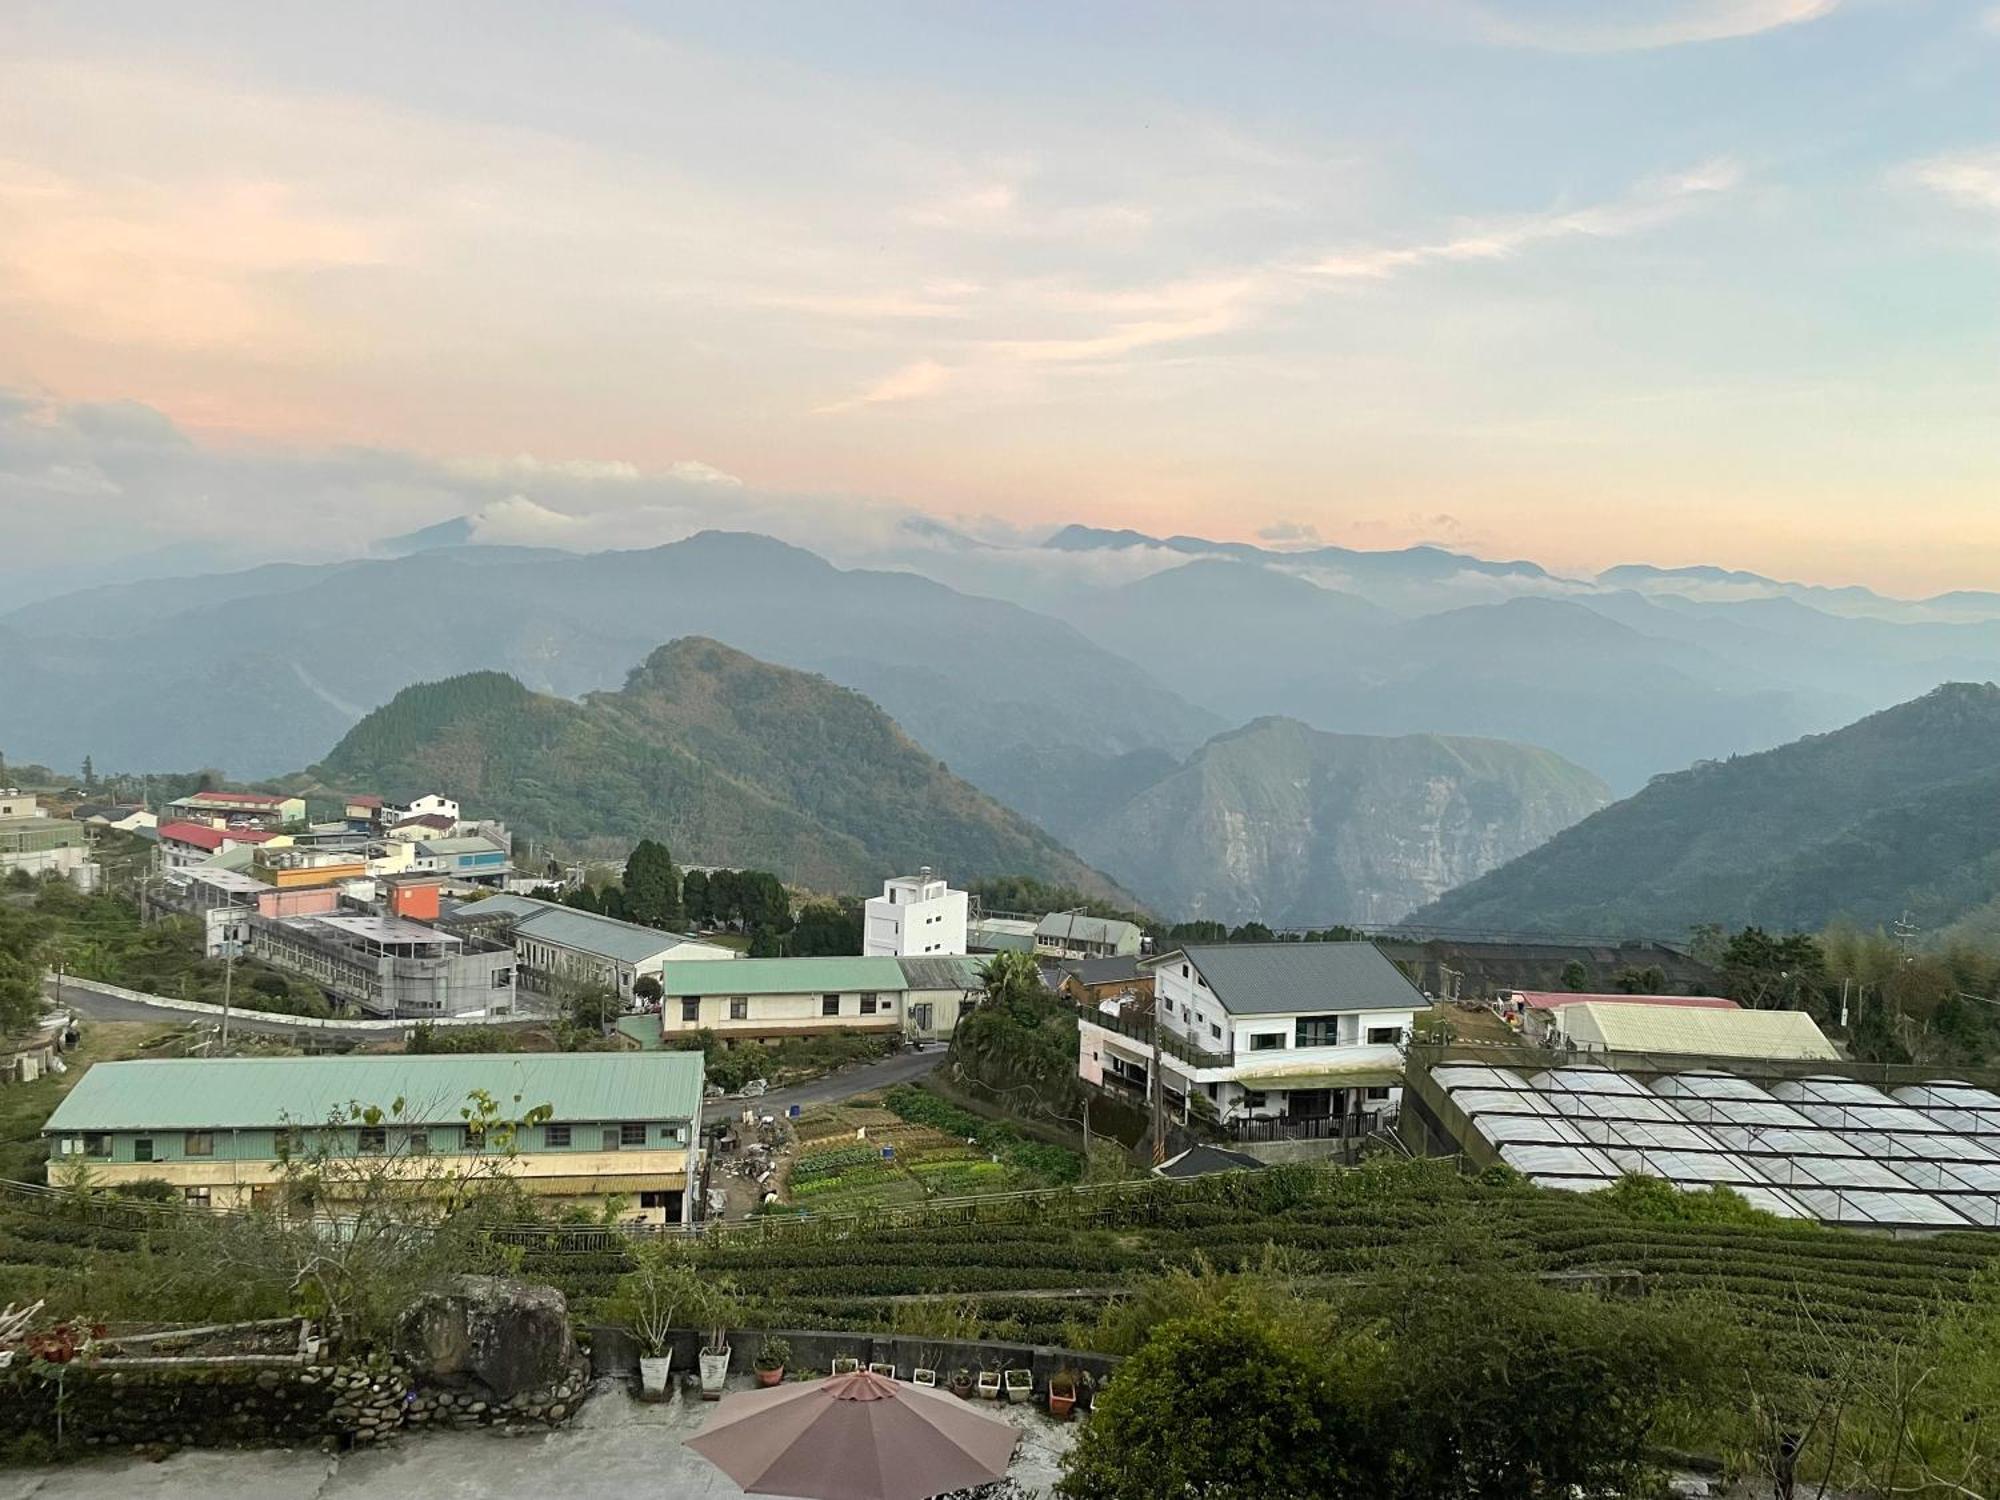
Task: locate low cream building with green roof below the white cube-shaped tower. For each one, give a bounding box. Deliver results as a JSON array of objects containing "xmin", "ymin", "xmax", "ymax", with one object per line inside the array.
[{"xmin": 660, "ymin": 954, "xmax": 982, "ymax": 1042}]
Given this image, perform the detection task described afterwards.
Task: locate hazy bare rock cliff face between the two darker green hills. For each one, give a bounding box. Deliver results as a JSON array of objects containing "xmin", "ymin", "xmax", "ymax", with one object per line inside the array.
[{"xmin": 1074, "ymin": 718, "xmax": 1610, "ymax": 926}]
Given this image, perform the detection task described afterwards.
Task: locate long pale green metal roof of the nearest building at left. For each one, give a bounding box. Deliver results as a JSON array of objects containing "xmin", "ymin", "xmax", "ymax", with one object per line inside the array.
[{"xmin": 42, "ymin": 1052, "xmax": 702, "ymax": 1132}]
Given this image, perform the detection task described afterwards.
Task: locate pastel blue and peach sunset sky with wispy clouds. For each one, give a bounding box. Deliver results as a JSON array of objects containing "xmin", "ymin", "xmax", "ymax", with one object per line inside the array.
[{"xmin": 0, "ymin": 0, "xmax": 2000, "ymax": 594}]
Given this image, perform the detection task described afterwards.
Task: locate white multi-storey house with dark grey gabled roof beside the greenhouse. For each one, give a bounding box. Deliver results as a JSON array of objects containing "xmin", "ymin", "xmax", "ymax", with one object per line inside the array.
[{"xmin": 1076, "ymin": 942, "xmax": 1428, "ymax": 1136}]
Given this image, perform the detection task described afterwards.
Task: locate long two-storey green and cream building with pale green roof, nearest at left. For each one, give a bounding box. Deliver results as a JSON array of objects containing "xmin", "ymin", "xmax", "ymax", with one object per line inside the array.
[{"xmin": 42, "ymin": 1052, "xmax": 702, "ymax": 1224}]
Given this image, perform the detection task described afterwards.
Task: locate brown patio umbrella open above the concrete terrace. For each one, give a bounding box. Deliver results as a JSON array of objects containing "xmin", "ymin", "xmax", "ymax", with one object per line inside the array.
[{"xmin": 688, "ymin": 1370, "xmax": 1020, "ymax": 1500}]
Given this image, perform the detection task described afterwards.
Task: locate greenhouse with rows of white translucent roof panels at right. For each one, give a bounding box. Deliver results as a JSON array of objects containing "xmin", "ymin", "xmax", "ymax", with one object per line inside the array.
[{"xmin": 1432, "ymin": 1064, "xmax": 2000, "ymax": 1228}]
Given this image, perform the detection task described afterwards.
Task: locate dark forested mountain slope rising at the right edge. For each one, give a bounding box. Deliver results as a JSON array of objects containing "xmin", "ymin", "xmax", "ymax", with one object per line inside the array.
[{"xmin": 1416, "ymin": 682, "xmax": 2000, "ymax": 938}]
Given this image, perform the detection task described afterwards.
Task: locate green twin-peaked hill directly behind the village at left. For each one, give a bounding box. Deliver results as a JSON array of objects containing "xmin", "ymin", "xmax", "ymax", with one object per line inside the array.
[{"xmin": 306, "ymin": 638, "xmax": 1124, "ymax": 896}]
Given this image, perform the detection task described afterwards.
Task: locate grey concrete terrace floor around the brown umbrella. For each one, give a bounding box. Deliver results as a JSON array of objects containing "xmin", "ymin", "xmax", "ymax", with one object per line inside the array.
[{"xmin": 0, "ymin": 1380, "xmax": 1076, "ymax": 1500}]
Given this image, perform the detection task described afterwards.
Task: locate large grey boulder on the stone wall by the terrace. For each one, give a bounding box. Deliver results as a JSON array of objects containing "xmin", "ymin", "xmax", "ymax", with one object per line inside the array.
[{"xmin": 400, "ymin": 1276, "xmax": 582, "ymax": 1400}]
